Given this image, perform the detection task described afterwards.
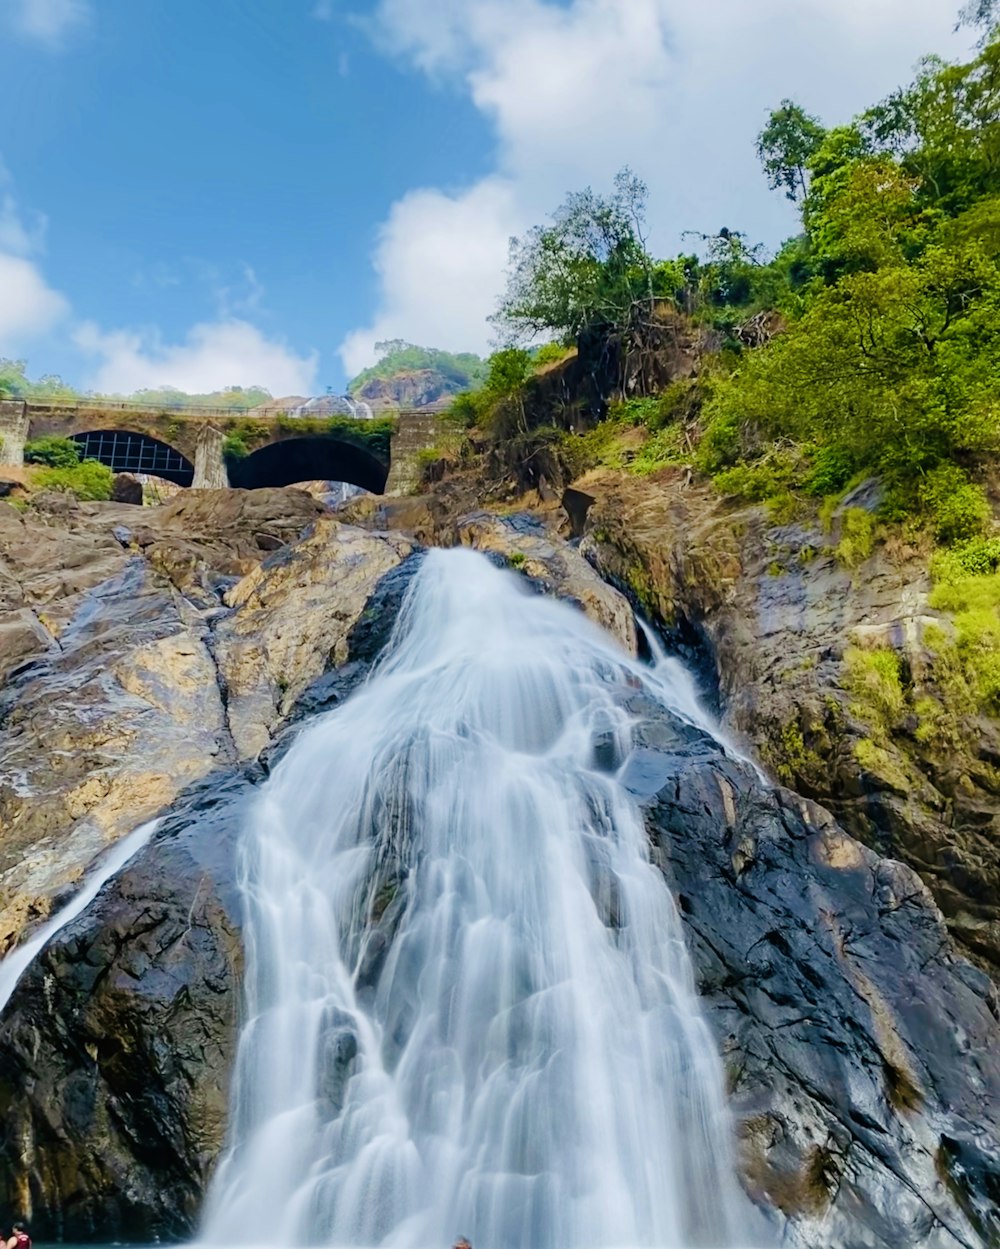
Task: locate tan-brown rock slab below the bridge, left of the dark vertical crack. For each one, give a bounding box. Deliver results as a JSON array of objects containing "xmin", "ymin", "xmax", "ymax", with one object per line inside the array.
[{"xmin": 0, "ymin": 491, "xmax": 323, "ymax": 950}]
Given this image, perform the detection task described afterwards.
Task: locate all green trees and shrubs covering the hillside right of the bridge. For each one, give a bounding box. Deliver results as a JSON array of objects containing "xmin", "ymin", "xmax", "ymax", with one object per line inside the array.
[{"xmin": 441, "ymin": 15, "xmax": 1000, "ymax": 563}]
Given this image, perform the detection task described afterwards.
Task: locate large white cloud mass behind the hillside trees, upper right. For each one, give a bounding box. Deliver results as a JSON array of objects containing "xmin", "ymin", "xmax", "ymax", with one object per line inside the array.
[{"xmin": 341, "ymin": 0, "xmax": 963, "ymax": 371}]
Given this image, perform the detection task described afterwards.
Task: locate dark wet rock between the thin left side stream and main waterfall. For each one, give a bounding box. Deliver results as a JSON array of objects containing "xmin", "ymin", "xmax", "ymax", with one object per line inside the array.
[{"xmin": 0, "ymin": 776, "xmax": 247, "ymax": 1243}]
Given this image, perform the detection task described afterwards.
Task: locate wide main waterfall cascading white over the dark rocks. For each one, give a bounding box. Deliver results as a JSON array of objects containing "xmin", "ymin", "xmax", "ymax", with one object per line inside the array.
[{"xmin": 205, "ymin": 551, "xmax": 740, "ymax": 1249}]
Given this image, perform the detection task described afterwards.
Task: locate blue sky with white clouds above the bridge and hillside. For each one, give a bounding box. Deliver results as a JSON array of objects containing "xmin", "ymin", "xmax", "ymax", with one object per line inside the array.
[{"xmin": 0, "ymin": 0, "xmax": 968, "ymax": 393}]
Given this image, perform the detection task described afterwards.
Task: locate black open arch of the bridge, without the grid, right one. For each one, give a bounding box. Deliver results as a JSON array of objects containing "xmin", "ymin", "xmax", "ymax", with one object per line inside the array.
[{"xmin": 226, "ymin": 436, "xmax": 388, "ymax": 495}]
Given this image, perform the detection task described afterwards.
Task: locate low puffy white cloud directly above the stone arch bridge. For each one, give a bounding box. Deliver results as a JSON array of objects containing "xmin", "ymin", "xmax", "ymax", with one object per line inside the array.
[{"xmin": 74, "ymin": 318, "xmax": 317, "ymax": 395}]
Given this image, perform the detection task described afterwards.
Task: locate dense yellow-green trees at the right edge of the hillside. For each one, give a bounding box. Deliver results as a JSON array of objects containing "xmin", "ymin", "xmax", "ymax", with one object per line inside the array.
[{"xmin": 699, "ymin": 40, "xmax": 1000, "ymax": 541}]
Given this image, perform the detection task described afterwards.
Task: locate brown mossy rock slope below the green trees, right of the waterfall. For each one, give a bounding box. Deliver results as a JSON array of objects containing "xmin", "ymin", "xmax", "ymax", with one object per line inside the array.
[{"xmin": 582, "ymin": 471, "xmax": 1000, "ymax": 979}]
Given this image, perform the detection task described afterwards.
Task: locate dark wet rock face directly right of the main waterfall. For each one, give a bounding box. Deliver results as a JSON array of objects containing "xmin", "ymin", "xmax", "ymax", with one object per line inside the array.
[{"xmin": 631, "ymin": 722, "xmax": 1000, "ymax": 1249}]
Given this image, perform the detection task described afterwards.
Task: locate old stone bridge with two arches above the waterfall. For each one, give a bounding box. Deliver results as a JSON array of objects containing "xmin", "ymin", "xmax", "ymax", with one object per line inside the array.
[{"xmin": 0, "ymin": 400, "xmax": 437, "ymax": 495}]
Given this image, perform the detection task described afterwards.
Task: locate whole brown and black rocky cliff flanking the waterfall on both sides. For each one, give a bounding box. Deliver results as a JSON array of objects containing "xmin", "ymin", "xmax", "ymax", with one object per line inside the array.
[{"xmin": 0, "ymin": 489, "xmax": 1000, "ymax": 1249}]
